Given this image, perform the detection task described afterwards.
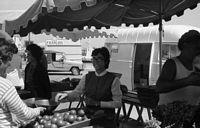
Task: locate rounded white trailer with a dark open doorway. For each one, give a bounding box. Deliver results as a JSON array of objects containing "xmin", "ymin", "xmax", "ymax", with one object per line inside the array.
[{"xmin": 105, "ymin": 25, "xmax": 200, "ymax": 90}]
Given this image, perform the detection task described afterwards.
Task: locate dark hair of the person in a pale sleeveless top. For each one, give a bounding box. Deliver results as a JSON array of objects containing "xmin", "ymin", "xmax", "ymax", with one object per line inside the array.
[{"xmin": 178, "ymin": 30, "xmax": 200, "ymax": 51}]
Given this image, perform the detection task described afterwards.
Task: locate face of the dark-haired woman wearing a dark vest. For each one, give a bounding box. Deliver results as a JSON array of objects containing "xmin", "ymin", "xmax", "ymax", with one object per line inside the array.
[{"xmin": 92, "ymin": 53, "xmax": 105, "ymax": 72}]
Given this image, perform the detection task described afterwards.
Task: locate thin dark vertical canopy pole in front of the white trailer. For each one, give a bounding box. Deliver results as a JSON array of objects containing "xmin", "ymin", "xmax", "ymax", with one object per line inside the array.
[{"xmin": 158, "ymin": 0, "xmax": 163, "ymax": 74}]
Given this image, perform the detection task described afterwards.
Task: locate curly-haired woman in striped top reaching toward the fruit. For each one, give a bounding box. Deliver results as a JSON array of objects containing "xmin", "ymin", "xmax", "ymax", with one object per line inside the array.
[{"xmin": 0, "ymin": 30, "xmax": 45, "ymax": 128}]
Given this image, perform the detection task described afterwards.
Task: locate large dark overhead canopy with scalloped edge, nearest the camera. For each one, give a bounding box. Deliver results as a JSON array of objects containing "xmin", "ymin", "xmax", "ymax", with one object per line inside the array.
[{"xmin": 5, "ymin": 0, "xmax": 200, "ymax": 36}]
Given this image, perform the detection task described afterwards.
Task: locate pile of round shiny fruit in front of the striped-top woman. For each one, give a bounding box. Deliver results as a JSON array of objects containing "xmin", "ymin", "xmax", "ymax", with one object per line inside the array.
[{"xmin": 21, "ymin": 109, "xmax": 87, "ymax": 128}]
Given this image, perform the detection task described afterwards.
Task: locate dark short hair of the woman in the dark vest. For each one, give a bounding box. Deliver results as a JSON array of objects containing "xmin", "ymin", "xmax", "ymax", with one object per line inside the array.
[{"xmin": 92, "ymin": 47, "xmax": 110, "ymax": 69}]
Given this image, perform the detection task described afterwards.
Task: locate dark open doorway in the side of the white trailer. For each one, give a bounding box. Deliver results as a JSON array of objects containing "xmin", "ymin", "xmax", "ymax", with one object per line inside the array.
[{"xmin": 133, "ymin": 43, "xmax": 152, "ymax": 87}]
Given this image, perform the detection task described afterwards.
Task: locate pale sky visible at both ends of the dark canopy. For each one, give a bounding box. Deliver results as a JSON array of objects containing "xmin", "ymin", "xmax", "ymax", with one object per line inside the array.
[{"xmin": 0, "ymin": 0, "xmax": 200, "ymax": 28}]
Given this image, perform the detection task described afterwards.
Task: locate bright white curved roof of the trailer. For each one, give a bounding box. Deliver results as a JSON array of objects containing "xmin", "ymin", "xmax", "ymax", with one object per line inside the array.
[{"xmin": 116, "ymin": 25, "xmax": 200, "ymax": 43}]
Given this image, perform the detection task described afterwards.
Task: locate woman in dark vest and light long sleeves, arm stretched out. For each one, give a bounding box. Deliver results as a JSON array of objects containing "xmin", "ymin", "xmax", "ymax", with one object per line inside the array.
[{"xmin": 56, "ymin": 47, "xmax": 122, "ymax": 128}]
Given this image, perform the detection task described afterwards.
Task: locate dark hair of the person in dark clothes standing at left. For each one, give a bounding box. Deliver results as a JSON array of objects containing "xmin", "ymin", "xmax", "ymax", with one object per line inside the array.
[{"xmin": 26, "ymin": 44, "xmax": 43, "ymax": 62}]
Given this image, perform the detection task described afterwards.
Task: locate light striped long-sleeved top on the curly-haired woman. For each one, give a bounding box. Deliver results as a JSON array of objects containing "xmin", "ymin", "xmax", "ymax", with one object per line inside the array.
[{"xmin": 0, "ymin": 77, "xmax": 40, "ymax": 128}]
